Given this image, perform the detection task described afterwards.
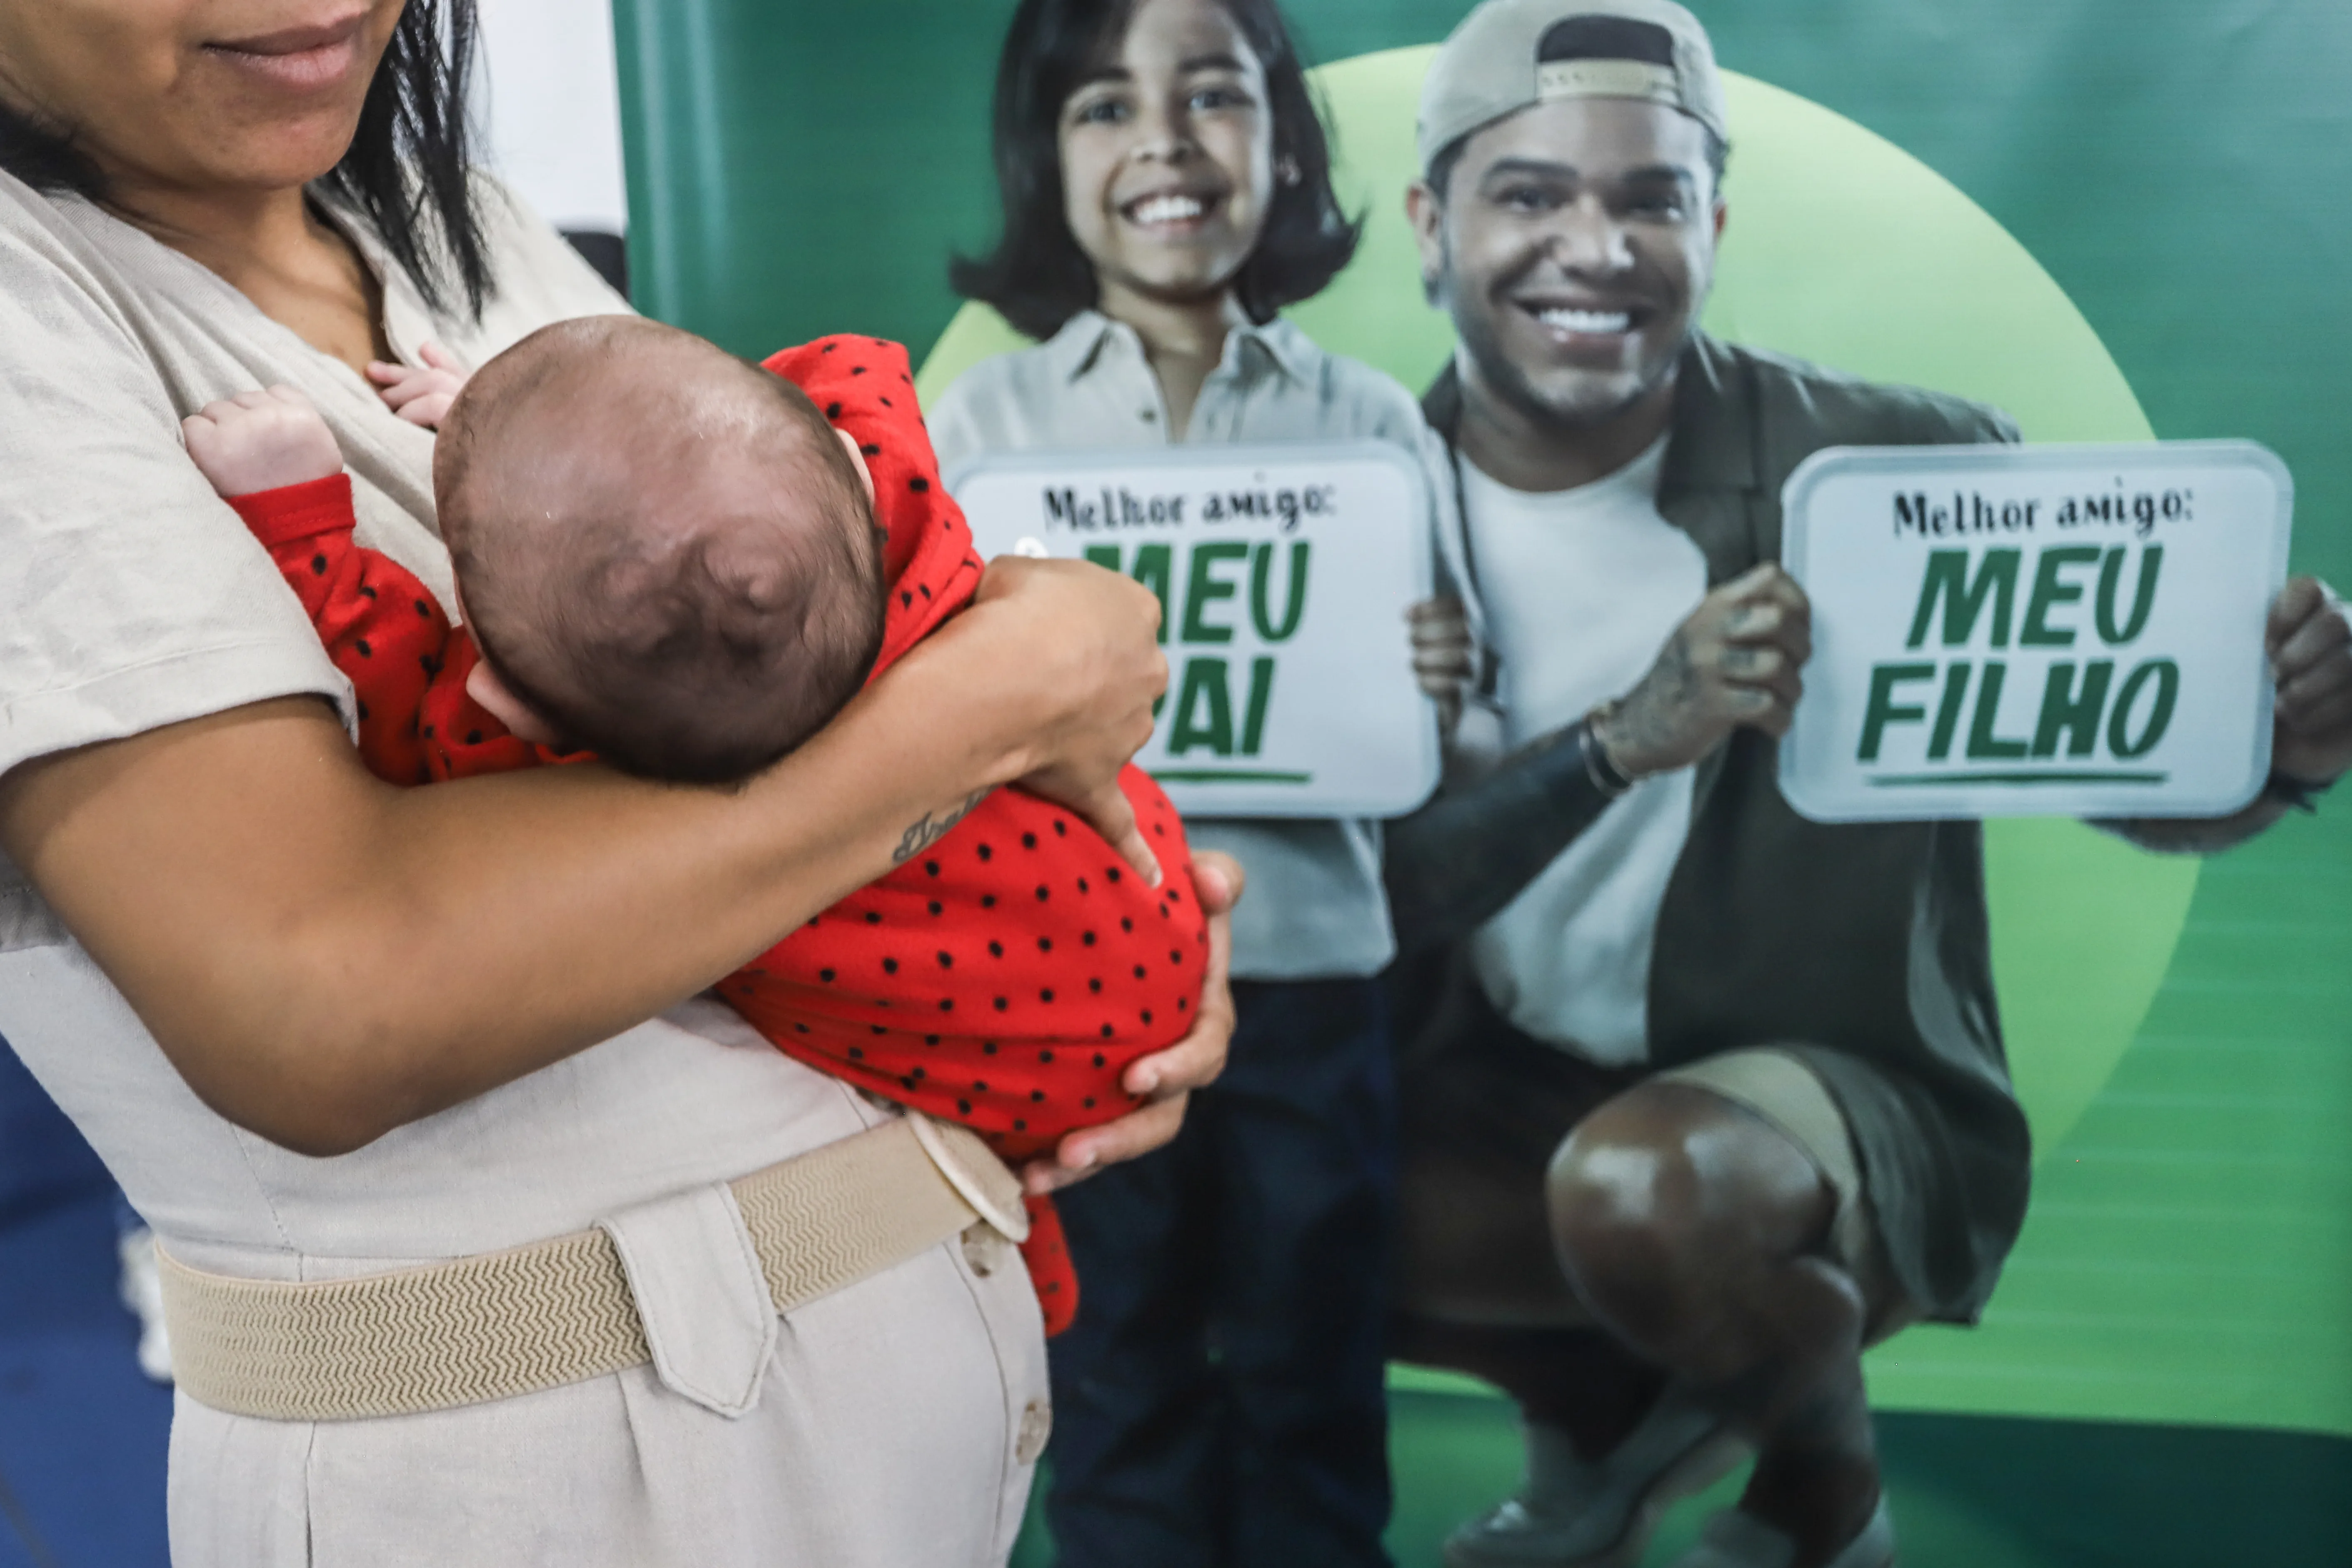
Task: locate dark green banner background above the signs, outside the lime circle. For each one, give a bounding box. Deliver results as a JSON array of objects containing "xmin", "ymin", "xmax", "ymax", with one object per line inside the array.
[{"xmin": 614, "ymin": 0, "xmax": 2352, "ymax": 606}]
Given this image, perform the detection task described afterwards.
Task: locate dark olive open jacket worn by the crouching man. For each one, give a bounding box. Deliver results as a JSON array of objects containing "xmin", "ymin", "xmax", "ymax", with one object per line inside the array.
[{"xmin": 1390, "ymin": 336, "xmax": 2030, "ymax": 1321}]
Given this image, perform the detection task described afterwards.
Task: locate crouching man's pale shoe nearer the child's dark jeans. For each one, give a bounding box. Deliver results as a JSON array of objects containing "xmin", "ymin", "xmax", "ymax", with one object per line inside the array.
[{"xmin": 1444, "ymin": 1387, "xmax": 1748, "ymax": 1568}]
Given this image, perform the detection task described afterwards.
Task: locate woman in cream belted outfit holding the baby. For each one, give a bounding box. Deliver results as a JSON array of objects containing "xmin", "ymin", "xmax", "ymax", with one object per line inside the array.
[{"xmin": 0, "ymin": 0, "xmax": 1237, "ymax": 1568}]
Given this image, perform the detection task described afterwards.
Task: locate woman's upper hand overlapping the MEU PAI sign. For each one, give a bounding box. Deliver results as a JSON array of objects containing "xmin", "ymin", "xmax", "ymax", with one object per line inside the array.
[{"xmin": 950, "ymin": 557, "xmax": 1169, "ymax": 886}]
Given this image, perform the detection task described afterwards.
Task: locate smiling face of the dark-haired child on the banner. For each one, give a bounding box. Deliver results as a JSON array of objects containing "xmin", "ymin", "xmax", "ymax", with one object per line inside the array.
[{"xmin": 1061, "ymin": 0, "xmax": 1275, "ymax": 315}]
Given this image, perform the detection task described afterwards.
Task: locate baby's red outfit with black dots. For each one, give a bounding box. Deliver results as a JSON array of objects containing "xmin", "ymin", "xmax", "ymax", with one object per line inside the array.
[{"xmin": 222, "ymin": 336, "xmax": 1209, "ymax": 1333}]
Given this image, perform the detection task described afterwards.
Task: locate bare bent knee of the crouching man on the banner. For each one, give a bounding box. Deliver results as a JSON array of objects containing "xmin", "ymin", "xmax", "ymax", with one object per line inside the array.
[{"xmin": 1545, "ymin": 1084, "xmax": 1837, "ymax": 1361}]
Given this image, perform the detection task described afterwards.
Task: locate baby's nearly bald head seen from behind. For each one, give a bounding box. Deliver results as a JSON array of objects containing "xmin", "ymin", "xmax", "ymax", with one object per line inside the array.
[{"xmin": 433, "ymin": 315, "xmax": 887, "ymax": 783}]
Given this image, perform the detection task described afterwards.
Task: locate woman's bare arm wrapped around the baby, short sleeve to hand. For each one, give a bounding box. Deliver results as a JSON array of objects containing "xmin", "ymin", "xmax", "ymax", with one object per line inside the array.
[{"xmin": 0, "ymin": 562, "xmax": 1166, "ymax": 1154}]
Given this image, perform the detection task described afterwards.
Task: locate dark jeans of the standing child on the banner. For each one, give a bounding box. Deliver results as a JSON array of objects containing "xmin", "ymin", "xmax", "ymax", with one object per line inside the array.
[{"xmin": 1046, "ymin": 980, "xmax": 1397, "ymax": 1568}]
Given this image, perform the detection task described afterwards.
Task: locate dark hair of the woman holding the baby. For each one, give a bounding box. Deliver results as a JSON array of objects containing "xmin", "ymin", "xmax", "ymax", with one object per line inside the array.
[{"xmin": 0, "ymin": 0, "xmax": 492, "ymax": 315}]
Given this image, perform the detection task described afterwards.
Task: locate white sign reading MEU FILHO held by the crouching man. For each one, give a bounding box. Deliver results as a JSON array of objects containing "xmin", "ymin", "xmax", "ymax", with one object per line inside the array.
[{"xmin": 1780, "ymin": 442, "xmax": 2293, "ymax": 823}]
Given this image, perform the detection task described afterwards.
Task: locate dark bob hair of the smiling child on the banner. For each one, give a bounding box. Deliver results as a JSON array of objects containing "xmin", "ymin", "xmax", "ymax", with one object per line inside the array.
[{"xmin": 948, "ymin": 0, "xmax": 1364, "ymax": 339}]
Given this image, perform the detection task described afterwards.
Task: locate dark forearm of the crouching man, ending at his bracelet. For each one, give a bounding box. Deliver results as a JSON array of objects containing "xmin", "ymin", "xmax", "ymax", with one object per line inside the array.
[{"xmin": 1385, "ymin": 724, "xmax": 1609, "ymax": 954}]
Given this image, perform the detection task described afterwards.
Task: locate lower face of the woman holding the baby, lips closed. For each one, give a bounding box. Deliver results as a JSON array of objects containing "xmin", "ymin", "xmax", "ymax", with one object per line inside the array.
[{"xmin": 0, "ymin": 0, "xmax": 404, "ymax": 193}]
